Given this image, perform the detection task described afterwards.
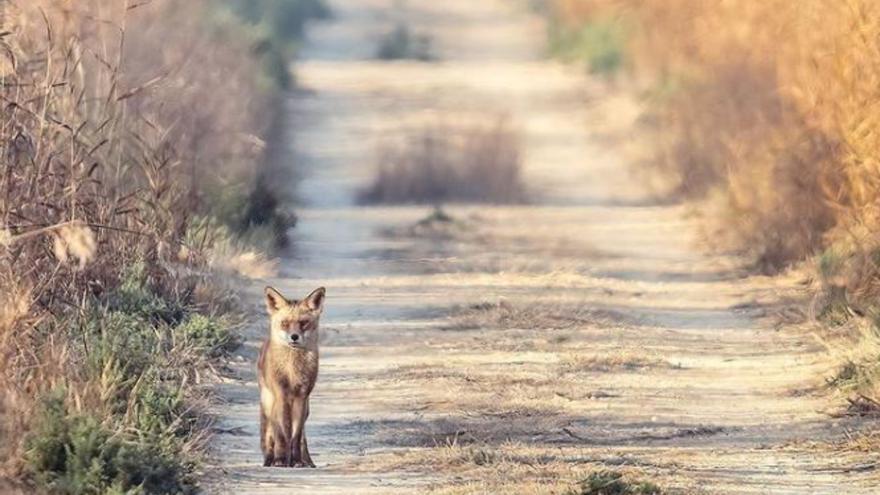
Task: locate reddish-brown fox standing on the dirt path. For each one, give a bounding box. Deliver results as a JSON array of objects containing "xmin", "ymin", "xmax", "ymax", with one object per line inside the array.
[{"xmin": 257, "ymin": 287, "xmax": 326, "ymax": 468}]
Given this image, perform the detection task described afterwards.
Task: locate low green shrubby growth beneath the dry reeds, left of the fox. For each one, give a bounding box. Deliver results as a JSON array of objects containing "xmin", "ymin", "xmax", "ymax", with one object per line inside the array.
[{"xmin": 25, "ymin": 263, "xmax": 237, "ymax": 494}]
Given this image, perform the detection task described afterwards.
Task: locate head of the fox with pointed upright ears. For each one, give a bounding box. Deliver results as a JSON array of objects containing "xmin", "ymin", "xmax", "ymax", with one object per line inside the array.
[{"xmin": 266, "ymin": 287, "xmax": 326, "ymax": 350}]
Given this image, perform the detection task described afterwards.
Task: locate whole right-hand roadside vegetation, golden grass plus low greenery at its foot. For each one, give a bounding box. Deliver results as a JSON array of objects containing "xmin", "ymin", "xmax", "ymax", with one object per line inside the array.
[{"xmin": 550, "ymin": 0, "xmax": 880, "ymax": 418}]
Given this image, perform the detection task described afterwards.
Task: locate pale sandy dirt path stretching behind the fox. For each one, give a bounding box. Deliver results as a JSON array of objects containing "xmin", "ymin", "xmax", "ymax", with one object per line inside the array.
[{"xmin": 211, "ymin": 0, "xmax": 871, "ymax": 494}]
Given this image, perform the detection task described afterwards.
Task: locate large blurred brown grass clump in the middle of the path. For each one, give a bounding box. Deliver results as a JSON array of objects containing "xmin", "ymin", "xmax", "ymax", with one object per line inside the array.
[{"xmin": 359, "ymin": 118, "xmax": 527, "ymax": 204}]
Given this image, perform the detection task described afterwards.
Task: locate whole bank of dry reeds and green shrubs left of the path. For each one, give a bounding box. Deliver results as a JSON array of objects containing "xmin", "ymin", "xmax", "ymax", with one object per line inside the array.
[{"xmin": 0, "ymin": 0, "xmax": 324, "ymax": 493}]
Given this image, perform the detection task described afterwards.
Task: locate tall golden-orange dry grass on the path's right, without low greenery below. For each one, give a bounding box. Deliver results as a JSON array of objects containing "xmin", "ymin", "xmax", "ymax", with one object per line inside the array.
[{"xmin": 555, "ymin": 0, "xmax": 880, "ymax": 276}]
